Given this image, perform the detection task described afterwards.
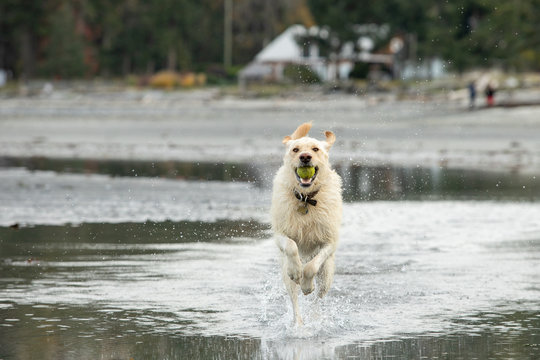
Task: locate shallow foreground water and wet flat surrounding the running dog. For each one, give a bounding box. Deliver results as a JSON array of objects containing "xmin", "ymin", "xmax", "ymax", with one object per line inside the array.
[{"xmin": 0, "ymin": 165, "xmax": 540, "ymax": 359}]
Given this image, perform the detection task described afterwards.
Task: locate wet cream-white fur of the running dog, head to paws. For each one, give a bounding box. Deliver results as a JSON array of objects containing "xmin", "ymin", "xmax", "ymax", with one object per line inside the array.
[{"xmin": 271, "ymin": 124, "xmax": 342, "ymax": 324}]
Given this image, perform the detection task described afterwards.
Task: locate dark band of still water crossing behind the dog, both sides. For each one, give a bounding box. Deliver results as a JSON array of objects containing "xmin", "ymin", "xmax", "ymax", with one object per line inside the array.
[{"xmin": 0, "ymin": 157, "xmax": 540, "ymax": 201}]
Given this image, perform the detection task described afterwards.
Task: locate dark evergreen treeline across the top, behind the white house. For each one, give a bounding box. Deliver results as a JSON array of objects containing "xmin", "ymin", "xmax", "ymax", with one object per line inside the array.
[{"xmin": 0, "ymin": 0, "xmax": 540, "ymax": 78}]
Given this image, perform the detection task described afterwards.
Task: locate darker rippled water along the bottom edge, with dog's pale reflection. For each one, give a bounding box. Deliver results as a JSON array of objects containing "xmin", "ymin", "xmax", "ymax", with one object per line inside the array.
[{"xmin": 0, "ymin": 304, "xmax": 540, "ymax": 360}]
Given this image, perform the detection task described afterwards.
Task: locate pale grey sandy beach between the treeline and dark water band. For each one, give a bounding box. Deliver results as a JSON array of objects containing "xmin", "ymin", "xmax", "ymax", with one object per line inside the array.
[{"xmin": 0, "ymin": 89, "xmax": 540, "ymax": 173}]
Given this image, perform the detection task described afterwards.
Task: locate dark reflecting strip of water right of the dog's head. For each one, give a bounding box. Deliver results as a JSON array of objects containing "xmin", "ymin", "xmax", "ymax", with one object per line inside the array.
[{"xmin": 337, "ymin": 164, "xmax": 540, "ymax": 201}]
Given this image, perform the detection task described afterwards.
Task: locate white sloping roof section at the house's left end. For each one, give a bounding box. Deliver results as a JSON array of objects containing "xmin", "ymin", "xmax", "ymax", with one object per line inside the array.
[{"xmin": 255, "ymin": 25, "xmax": 306, "ymax": 62}]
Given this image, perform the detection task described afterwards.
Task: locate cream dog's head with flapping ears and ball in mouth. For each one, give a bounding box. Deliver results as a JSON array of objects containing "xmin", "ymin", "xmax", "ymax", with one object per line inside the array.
[{"xmin": 283, "ymin": 123, "xmax": 336, "ymax": 189}]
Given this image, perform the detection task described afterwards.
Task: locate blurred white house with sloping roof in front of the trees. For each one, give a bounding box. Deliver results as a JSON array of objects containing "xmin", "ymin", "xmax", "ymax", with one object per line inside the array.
[{"xmin": 239, "ymin": 24, "xmax": 445, "ymax": 85}]
